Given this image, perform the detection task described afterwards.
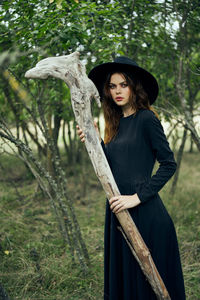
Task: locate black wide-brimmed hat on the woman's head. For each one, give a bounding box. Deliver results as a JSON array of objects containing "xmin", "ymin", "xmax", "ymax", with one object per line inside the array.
[{"xmin": 88, "ymin": 56, "xmax": 159, "ymax": 104}]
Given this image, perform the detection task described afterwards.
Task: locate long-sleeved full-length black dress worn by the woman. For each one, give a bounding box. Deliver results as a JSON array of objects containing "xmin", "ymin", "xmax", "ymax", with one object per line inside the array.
[{"xmin": 102, "ymin": 109, "xmax": 185, "ymax": 300}]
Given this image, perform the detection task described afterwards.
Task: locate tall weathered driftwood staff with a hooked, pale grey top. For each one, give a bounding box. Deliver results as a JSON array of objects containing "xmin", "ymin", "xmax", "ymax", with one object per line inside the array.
[{"xmin": 25, "ymin": 52, "xmax": 170, "ymax": 300}]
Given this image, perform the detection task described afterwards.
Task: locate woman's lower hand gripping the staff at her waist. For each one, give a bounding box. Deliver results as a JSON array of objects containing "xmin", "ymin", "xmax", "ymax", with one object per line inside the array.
[{"xmin": 109, "ymin": 194, "xmax": 141, "ymax": 214}]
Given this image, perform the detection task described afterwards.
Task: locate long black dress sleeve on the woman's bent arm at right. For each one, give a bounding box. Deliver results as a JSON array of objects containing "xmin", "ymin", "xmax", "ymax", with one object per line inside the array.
[{"xmin": 136, "ymin": 111, "xmax": 176, "ymax": 202}]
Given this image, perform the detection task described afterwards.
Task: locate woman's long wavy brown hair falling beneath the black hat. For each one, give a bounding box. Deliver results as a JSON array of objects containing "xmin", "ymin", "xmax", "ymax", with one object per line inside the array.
[{"xmin": 102, "ymin": 71, "xmax": 158, "ymax": 144}]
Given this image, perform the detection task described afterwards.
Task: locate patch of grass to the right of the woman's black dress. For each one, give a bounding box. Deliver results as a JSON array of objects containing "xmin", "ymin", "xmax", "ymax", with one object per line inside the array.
[{"xmin": 160, "ymin": 153, "xmax": 200, "ymax": 300}]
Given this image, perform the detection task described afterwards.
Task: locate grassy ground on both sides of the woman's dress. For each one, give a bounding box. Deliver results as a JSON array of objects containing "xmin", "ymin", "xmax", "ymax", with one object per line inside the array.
[{"xmin": 0, "ymin": 153, "xmax": 200, "ymax": 300}]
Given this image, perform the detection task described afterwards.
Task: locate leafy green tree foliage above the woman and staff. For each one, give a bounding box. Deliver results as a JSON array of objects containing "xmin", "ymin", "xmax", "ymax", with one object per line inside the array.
[{"xmin": 0, "ymin": 0, "xmax": 200, "ymax": 124}]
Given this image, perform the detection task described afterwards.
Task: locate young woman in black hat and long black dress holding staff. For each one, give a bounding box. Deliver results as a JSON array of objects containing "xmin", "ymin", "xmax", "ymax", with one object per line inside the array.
[{"xmin": 77, "ymin": 57, "xmax": 185, "ymax": 300}]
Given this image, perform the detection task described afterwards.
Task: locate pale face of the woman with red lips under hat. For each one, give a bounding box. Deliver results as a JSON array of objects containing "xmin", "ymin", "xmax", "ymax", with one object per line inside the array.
[{"xmin": 109, "ymin": 73, "xmax": 131, "ymax": 107}]
